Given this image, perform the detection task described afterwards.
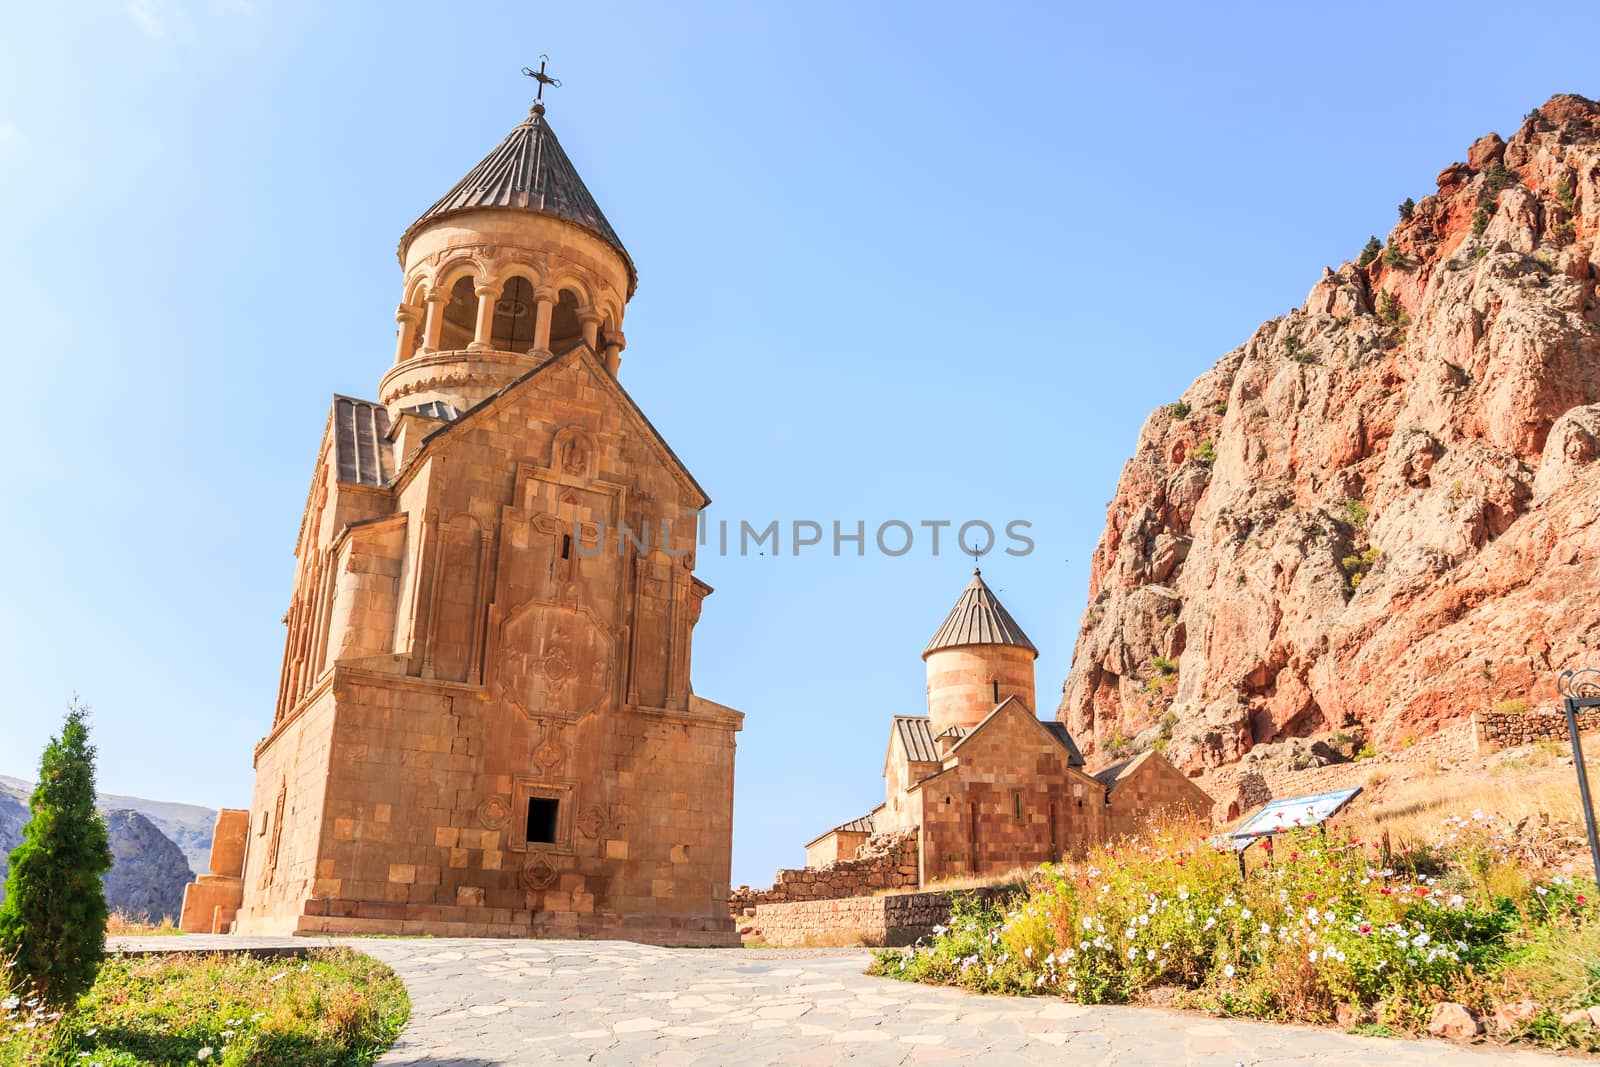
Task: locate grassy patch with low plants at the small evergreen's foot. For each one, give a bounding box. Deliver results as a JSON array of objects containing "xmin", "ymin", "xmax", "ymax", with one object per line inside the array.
[{"xmin": 0, "ymin": 949, "xmax": 411, "ymax": 1067}]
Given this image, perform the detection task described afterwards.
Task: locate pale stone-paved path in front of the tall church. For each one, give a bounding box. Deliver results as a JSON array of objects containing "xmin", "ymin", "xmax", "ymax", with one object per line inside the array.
[{"xmin": 112, "ymin": 936, "xmax": 1574, "ymax": 1067}]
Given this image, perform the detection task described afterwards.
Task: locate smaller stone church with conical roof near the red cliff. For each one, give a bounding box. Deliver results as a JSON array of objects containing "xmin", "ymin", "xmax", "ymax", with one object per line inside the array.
[{"xmin": 793, "ymin": 569, "xmax": 1211, "ymax": 897}]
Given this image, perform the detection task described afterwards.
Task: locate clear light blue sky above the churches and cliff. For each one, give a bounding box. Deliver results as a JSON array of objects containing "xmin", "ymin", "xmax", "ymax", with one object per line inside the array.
[{"xmin": 0, "ymin": 0, "xmax": 1600, "ymax": 883}]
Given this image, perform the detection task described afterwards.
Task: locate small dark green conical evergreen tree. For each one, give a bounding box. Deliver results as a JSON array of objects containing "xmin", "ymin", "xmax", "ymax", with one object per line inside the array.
[{"xmin": 0, "ymin": 699, "xmax": 112, "ymax": 1005}]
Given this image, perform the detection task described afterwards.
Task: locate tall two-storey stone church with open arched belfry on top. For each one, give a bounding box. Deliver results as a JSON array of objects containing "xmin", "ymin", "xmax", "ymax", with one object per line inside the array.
[{"xmin": 184, "ymin": 91, "xmax": 742, "ymax": 945}]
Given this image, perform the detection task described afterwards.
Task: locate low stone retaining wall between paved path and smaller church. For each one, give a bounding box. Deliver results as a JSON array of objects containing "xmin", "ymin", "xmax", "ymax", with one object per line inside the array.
[{"xmin": 741, "ymin": 886, "xmax": 1016, "ymax": 949}]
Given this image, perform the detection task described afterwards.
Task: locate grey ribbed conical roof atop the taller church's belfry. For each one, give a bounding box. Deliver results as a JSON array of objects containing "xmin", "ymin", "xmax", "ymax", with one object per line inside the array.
[{"xmin": 400, "ymin": 104, "xmax": 638, "ymax": 296}]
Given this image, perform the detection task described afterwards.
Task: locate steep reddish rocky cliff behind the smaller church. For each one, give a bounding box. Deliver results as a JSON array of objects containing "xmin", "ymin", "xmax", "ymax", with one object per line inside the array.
[{"xmin": 1058, "ymin": 96, "xmax": 1600, "ymax": 773}]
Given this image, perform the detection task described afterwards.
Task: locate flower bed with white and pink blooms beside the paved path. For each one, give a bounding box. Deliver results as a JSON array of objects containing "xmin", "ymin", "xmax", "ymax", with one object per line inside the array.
[{"xmin": 874, "ymin": 813, "xmax": 1600, "ymax": 1049}]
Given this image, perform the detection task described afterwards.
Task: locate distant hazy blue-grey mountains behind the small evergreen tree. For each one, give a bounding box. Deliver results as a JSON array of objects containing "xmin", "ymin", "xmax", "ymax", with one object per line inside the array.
[{"xmin": 0, "ymin": 776, "xmax": 216, "ymax": 920}]
